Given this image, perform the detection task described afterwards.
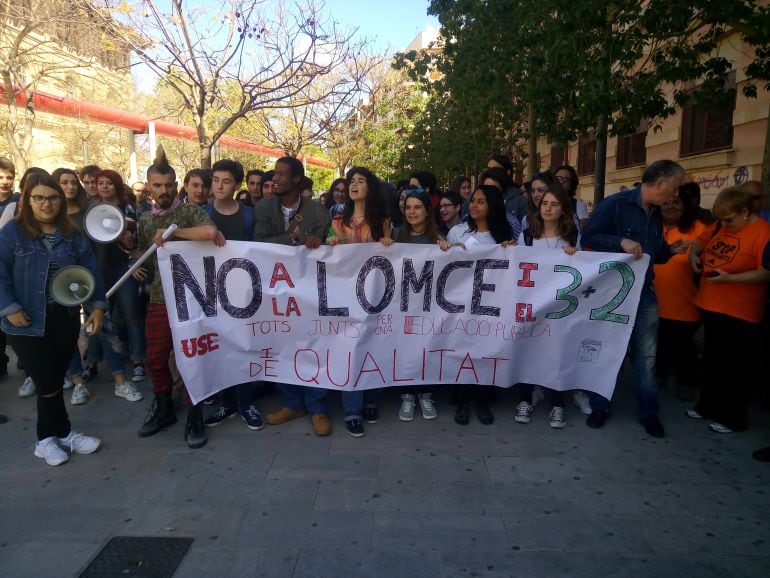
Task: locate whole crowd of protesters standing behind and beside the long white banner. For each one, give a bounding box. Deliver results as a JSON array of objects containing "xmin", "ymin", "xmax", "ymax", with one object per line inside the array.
[{"xmin": 0, "ymin": 151, "xmax": 770, "ymax": 465}]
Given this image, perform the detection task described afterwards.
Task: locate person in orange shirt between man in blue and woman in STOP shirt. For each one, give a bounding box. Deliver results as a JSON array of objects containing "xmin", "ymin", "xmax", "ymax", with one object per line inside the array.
[{"xmin": 654, "ymin": 191, "xmax": 706, "ymax": 401}]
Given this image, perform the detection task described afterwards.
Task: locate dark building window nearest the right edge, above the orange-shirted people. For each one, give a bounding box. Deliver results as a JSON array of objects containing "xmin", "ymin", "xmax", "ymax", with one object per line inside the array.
[{"xmin": 680, "ymin": 71, "xmax": 735, "ymax": 156}]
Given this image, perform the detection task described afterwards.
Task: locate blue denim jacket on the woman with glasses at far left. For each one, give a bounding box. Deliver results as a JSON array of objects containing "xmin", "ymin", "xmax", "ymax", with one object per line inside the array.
[{"xmin": 0, "ymin": 221, "xmax": 107, "ymax": 337}]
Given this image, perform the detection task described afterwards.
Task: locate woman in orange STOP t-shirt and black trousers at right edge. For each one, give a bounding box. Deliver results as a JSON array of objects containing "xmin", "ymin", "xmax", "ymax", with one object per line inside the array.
[{"xmin": 687, "ymin": 187, "xmax": 770, "ymax": 433}]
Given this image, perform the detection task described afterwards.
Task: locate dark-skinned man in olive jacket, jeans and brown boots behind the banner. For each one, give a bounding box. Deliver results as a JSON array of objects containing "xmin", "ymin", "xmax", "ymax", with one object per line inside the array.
[{"xmin": 254, "ymin": 157, "xmax": 332, "ymax": 436}]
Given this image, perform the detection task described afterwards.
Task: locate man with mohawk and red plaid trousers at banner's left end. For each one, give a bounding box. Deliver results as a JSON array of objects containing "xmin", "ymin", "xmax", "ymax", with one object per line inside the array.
[{"xmin": 134, "ymin": 147, "xmax": 225, "ymax": 448}]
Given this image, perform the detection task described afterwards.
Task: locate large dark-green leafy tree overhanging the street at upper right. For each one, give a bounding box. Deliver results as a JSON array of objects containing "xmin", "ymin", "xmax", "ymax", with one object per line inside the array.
[{"xmin": 406, "ymin": 0, "xmax": 767, "ymax": 201}]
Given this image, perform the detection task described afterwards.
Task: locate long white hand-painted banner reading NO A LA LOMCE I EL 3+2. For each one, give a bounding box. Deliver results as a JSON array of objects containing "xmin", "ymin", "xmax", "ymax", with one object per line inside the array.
[{"xmin": 158, "ymin": 242, "xmax": 648, "ymax": 402}]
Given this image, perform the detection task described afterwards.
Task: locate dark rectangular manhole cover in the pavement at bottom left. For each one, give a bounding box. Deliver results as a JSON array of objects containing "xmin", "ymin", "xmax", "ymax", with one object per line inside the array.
[{"xmin": 80, "ymin": 536, "xmax": 193, "ymax": 578}]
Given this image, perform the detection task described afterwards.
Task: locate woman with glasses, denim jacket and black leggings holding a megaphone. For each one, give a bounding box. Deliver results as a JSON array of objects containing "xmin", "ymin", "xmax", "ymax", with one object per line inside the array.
[{"xmin": 0, "ymin": 174, "xmax": 106, "ymax": 466}]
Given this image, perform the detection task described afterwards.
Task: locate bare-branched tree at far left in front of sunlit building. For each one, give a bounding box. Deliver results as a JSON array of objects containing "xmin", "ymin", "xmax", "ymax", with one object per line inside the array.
[{"xmin": 0, "ymin": 0, "xmax": 128, "ymax": 173}]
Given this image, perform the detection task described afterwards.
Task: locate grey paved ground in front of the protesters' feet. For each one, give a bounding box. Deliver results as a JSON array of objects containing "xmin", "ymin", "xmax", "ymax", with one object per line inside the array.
[{"xmin": 0, "ymin": 362, "xmax": 770, "ymax": 578}]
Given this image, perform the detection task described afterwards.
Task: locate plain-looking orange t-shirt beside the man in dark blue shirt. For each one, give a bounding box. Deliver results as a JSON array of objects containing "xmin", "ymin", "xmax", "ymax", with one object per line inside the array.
[{"xmin": 653, "ymin": 221, "xmax": 706, "ymax": 321}]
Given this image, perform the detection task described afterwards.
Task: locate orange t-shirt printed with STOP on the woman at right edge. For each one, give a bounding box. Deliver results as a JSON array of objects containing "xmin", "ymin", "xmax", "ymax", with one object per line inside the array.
[{"xmin": 695, "ymin": 219, "xmax": 770, "ymax": 323}]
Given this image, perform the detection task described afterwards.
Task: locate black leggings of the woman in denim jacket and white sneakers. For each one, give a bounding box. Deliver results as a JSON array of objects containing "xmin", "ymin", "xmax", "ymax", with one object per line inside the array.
[{"xmin": 8, "ymin": 305, "xmax": 80, "ymax": 440}]
